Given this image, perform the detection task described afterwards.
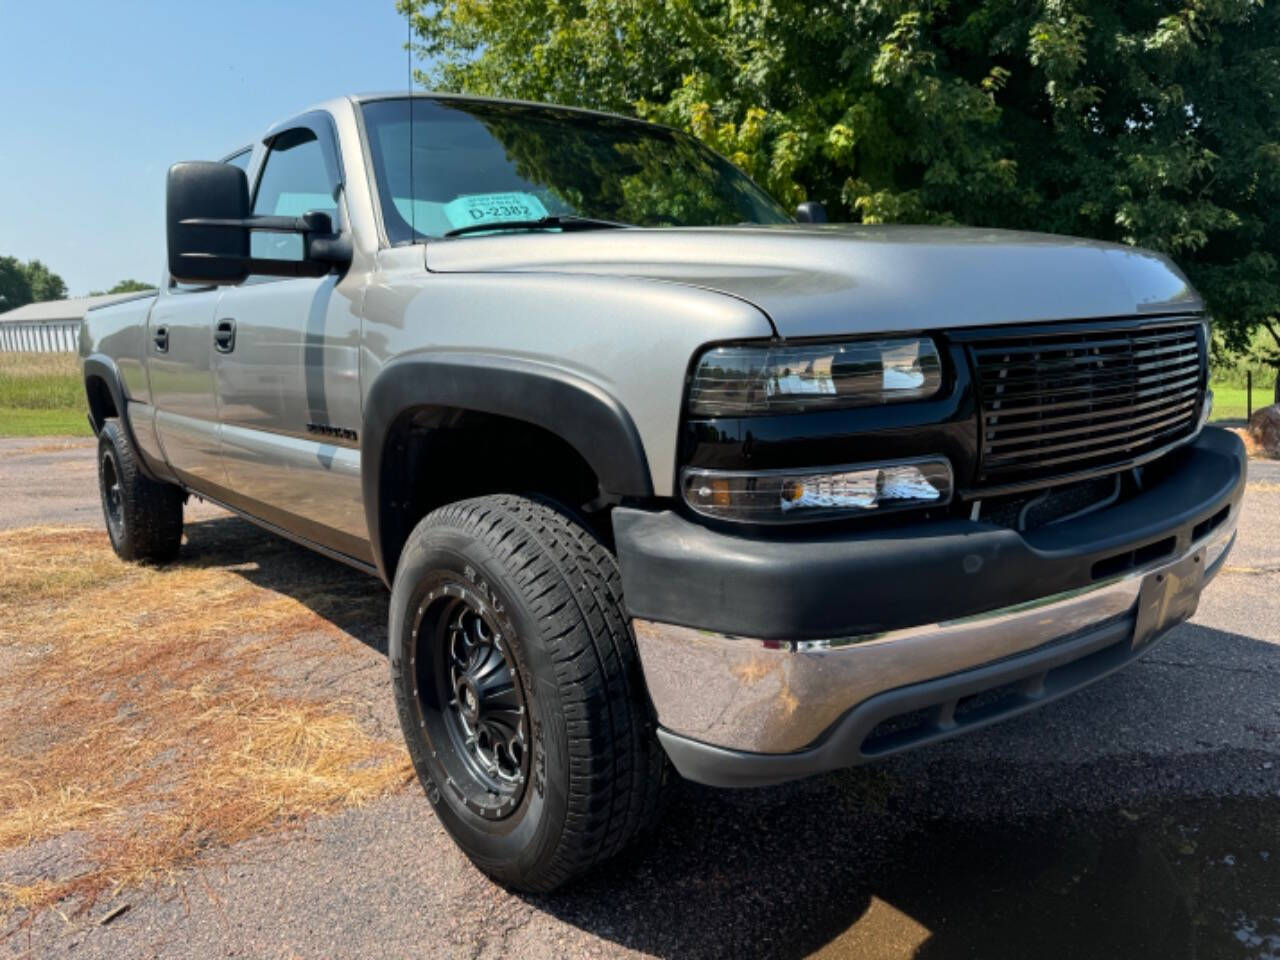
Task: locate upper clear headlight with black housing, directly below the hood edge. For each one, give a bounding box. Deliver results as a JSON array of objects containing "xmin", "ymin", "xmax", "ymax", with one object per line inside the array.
[{"xmin": 689, "ymin": 337, "xmax": 942, "ymax": 417}]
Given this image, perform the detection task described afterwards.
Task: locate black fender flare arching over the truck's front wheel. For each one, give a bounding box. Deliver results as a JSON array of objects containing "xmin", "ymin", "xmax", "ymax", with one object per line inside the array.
[{"xmin": 360, "ymin": 352, "xmax": 653, "ymax": 584}]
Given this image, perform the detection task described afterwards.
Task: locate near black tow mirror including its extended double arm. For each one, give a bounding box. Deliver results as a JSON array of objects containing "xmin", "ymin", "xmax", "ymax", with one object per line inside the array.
[{"xmin": 165, "ymin": 161, "xmax": 351, "ymax": 285}]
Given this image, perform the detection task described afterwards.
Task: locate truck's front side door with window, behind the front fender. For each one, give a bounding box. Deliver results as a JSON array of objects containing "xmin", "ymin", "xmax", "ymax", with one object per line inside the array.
[{"xmin": 214, "ymin": 114, "xmax": 371, "ymax": 561}]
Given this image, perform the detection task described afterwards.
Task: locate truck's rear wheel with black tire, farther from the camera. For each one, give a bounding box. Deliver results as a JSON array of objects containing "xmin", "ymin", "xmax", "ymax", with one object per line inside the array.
[{"xmin": 97, "ymin": 419, "xmax": 186, "ymax": 563}]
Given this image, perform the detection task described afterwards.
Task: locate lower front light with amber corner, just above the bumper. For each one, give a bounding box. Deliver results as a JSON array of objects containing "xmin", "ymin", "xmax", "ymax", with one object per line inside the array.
[{"xmin": 681, "ymin": 457, "xmax": 952, "ymax": 524}]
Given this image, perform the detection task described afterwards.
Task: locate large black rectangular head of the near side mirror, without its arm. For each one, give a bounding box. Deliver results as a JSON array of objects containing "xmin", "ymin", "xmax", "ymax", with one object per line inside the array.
[{"xmin": 165, "ymin": 161, "xmax": 250, "ymax": 285}]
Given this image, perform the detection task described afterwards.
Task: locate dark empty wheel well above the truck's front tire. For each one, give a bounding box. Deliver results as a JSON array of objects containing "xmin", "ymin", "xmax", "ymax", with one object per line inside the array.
[{"xmin": 379, "ymin": 406, "xmax": 612, "ymax": 571}]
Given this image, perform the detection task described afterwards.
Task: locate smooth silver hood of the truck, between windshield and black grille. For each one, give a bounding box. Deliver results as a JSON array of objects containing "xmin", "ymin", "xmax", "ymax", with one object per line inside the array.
[{"xmin": 426, "ymin": 224, "xmax": 1203, "ymax": 337}]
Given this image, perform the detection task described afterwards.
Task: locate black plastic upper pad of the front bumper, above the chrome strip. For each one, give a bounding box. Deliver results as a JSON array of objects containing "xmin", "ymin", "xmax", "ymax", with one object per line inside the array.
[{"xmin": 613, "ymin": 428, "xmax": 1245, "ymax": 640}]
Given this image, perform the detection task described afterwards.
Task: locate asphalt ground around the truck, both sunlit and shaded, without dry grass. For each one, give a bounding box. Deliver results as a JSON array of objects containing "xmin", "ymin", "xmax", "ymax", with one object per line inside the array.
[{"xmin": 0, "ymin": 440, "xmax": 1280, "ymax": 960}]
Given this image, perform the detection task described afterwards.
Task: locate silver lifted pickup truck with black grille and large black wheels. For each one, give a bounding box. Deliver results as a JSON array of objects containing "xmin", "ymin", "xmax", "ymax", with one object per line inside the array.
[{"xmin": 81, "ymin": 95, "xmax": 1245, "ymax": 890}]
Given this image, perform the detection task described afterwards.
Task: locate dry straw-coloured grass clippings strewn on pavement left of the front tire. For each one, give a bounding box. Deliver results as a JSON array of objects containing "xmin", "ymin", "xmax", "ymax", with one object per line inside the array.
[{"xmin": 0, "ymin": 529, "xmax": 410, "ymax": 918}]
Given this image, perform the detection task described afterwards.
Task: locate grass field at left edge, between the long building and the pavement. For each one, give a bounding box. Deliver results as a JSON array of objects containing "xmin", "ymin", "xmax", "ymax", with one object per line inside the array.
[{"xmin": 0, "ymin": 353, "xmax": 90, "ymax": 436}]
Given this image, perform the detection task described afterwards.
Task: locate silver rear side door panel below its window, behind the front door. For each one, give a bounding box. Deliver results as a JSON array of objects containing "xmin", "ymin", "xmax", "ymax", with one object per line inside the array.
[{"xmin": 146, "ymin": 282, "xmax": 224, "ymax": 488}]
